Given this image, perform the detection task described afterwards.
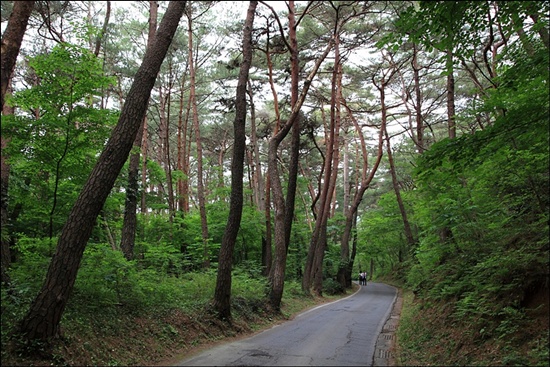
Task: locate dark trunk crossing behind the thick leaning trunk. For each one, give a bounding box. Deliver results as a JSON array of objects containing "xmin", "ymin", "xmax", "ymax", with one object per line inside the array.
[{"xmin": 120, "ymin": 1, "xmax": 158, "ymax": 260}]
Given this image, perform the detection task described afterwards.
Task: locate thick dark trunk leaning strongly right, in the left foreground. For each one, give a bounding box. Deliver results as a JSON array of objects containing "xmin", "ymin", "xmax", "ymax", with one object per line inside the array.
[{"xmin": 20, "ymin": 1, "xmax": 186, "ymax": 341}]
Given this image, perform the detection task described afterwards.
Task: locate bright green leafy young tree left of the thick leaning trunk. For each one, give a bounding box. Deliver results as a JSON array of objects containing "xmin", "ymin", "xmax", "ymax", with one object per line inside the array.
[{"xmin": 2, "ymin": 43, "xmax": 117, "ymax": 236}]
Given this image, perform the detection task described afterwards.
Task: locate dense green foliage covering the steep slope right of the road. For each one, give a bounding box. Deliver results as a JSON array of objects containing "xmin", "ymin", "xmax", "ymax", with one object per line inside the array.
[{"xmin": 408, "ymin": 41, "xmax": 550, "ymax": 346}]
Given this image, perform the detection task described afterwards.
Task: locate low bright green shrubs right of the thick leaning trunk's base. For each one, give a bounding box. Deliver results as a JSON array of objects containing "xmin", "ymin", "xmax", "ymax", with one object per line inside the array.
[{"xmin": 70, "ymin": 244, "xmax": 266, "ymax": 312}]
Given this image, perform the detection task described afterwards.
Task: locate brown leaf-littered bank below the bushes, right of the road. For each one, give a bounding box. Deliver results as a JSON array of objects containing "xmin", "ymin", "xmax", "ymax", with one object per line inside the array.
[{"xmin": 393, "ymin": 287, "xmax": 550, "ymax": 366}]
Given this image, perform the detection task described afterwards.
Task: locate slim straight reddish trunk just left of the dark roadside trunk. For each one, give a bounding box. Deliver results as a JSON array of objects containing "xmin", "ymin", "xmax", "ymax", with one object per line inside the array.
[{"xmin": 187, "ymin": 7, "xmax": 210, "ymax": 269}]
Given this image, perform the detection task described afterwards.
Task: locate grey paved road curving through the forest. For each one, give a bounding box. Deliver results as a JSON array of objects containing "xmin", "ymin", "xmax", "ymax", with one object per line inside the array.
[{"xmin": 175, "ymin": 282, "xmax": 397, "ymax": 366}]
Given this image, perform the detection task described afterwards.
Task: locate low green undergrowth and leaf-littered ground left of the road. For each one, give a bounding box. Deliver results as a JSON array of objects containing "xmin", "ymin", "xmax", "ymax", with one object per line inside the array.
[{"xmin": 1, "ymin": 253, "xmax": 351, "ymax": 366}]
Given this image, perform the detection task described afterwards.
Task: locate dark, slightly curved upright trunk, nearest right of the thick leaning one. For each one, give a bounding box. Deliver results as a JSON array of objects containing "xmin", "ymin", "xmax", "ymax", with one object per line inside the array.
[{"xmin": 214, "ymin": 1, "xmax": 258, "ymax": 319}]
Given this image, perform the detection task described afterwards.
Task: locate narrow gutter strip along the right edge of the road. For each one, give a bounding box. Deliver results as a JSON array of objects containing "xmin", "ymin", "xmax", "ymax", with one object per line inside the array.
[{"xmin": 372, "ymin": 288, "xmax": 403, "ymax": 366}]
